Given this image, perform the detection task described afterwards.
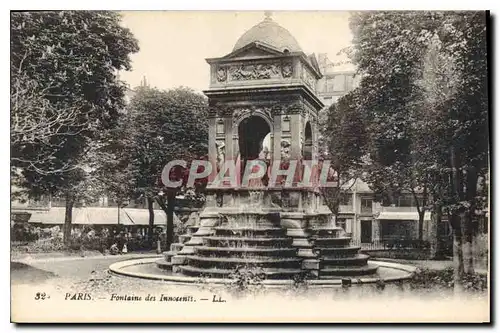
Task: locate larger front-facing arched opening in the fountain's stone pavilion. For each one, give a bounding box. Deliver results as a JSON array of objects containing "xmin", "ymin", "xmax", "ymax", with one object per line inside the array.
[{"xmin": 238, "ymin": 115, "xmax": 271, "ymax": 182}]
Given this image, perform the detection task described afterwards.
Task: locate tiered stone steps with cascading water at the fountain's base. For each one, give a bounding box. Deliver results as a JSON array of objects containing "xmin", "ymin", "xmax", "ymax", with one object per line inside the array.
[{"xmin": 157, "ymin": 223, "xmax": 377, "ymax": 279}]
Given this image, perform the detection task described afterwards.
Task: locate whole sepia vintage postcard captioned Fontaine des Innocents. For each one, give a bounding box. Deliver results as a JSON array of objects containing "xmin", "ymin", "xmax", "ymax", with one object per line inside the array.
[{"xmin": 10, "ymin": 10, "xmax": 491, "ymax": 323}]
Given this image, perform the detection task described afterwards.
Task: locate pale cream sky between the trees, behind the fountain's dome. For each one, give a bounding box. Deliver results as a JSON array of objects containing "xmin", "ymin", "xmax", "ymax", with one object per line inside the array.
[{"xmin": 120, "ymin": 11, "xmax": 352, "ymax": 92}]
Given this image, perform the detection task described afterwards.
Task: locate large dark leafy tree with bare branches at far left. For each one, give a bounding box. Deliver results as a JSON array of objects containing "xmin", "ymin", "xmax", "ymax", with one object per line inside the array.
[{"xmin": 11, "ymin": 11, "xmax": 138, "ymax": 242}]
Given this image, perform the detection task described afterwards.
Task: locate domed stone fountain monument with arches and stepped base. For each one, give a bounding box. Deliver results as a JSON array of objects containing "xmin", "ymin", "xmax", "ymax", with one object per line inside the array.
[{"xmin": 157, "ymin": 14, "xmax": 377, "ymax": 279}]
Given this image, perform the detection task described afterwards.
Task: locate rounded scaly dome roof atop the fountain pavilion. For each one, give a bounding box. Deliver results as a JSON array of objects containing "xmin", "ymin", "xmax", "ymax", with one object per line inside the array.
[{"xmin": 233, "ymin": 13, "xmax": 302, "ymax": 52}]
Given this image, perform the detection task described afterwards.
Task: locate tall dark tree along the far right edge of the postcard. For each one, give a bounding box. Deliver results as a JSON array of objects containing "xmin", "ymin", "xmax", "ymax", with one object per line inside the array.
[{"xmin": 438, "ymin": 12, "xmax": 489, "ymax": 273}]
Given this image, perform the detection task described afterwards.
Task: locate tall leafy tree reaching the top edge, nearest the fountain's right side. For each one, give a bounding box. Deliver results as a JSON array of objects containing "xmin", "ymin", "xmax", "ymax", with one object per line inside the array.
[{"xmin": 351, "ymin": 12, "xmax": 439, "ymax": 239}]
